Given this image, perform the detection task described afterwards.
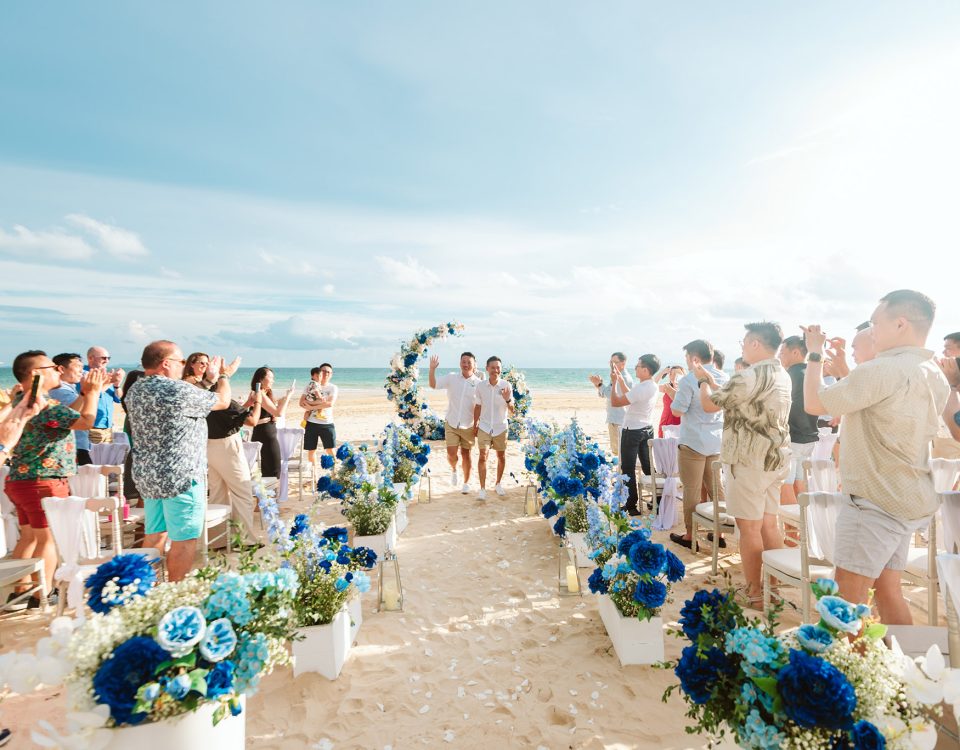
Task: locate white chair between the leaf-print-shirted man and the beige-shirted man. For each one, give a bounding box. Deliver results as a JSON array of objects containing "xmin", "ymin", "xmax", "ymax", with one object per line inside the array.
[{"xmin": 760, "ymin": 492, "xmax": 844, "ymax": 622}]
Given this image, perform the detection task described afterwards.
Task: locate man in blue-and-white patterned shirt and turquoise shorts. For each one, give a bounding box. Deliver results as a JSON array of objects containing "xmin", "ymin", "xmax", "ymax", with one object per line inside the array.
[{"xmin": 126, "ymin": 341, "xmax": 230, "ymax": 581}]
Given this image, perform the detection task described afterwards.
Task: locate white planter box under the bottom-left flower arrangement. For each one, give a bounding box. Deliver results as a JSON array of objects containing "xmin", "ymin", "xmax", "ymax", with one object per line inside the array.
[{"xmin": 106, "ymin": 696, "xmax": 247, "ymax": 750}]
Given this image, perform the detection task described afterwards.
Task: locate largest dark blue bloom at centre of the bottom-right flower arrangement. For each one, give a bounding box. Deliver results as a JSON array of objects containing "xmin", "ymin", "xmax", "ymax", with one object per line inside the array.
[{"xmin": 778, "ymin": 649, "xmax": 857, "ymax": 729}]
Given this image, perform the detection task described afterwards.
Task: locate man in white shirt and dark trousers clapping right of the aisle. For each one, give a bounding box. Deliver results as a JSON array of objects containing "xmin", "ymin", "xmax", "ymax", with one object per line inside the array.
[{"xmin": 610, "ymin": 354, "xmax": 660, "ymax": 516}]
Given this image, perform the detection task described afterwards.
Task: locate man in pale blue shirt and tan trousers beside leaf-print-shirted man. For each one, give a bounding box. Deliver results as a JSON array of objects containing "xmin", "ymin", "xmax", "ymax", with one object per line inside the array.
[{"xmin": 670, "ymin": 339, "xmax": 727, "ymax": 548}]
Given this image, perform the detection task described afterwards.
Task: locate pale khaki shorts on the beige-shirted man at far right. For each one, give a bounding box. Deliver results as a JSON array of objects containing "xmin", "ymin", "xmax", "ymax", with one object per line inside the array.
[{"xmin": 833, "ymin": 497, "xmax": 930, "ymax": 580}]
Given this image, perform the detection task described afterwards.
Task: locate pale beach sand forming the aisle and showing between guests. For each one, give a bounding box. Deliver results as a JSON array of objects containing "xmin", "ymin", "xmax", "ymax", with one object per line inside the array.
[{"xmin": 0, "ymin": 386, "xmax": 940, "ymax": 750}]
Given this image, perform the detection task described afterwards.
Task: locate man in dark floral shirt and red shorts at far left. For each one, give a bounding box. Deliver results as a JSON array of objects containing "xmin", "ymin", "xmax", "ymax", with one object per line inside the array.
[{"xmin": 4, "ymin": 350, "xmax": 103, "ymax": 606}]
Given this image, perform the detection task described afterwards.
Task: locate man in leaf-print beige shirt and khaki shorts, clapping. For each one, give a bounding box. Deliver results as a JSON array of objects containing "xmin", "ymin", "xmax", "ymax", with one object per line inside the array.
[{"xmin": 694, "ymin": 322, "xmax": 791, "ymax": 609}]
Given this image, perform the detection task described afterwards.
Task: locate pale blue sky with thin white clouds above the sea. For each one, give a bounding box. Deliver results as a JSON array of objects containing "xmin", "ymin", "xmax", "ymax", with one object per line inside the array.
[{"xmin": 0, "ymin": 0, "xmax": 960, "ymax": 367}]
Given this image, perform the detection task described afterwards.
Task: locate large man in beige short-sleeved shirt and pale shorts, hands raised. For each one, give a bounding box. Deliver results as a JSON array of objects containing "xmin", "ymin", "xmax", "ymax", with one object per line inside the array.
[{"xmin": 803, "ymin": 289, "xmax": 950, "ymax": 625}]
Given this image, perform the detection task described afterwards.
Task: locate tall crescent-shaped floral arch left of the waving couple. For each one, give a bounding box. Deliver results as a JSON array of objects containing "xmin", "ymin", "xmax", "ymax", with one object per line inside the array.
[{"xmin": 383, "ymin": 322, "xmax": 463, "ymax": 440}]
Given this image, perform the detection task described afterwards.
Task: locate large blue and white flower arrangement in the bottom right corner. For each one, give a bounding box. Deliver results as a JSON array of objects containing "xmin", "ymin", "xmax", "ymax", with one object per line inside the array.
[{"xmin": 664, "ymin": 579, "xmax": 942, "ymax": 750}]
